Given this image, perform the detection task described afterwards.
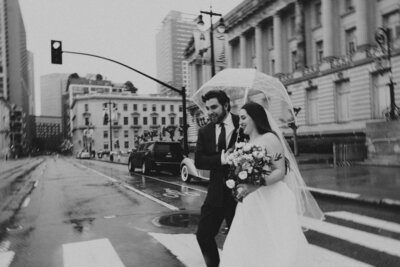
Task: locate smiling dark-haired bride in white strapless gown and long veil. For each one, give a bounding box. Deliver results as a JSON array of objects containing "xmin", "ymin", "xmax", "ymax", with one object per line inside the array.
[{"xmin": 220, "ymin": 102, "xmax": 323, "ymax": 267}]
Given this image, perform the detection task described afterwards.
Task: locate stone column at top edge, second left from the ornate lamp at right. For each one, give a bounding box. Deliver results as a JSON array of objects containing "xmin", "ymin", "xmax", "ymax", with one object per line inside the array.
[{"xmin": 321, "ymin": 0, "xmax": 336, "ymax": 58}]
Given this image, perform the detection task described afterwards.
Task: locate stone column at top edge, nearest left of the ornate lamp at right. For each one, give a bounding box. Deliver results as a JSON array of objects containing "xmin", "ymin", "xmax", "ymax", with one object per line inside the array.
[{"xmin": 354, "ymin": 0, "xmax": 369, "ymax": 48}]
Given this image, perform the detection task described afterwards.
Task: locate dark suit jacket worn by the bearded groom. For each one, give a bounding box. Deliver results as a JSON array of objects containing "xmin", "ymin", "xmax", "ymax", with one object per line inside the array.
[{"xmin": 195, "ymin": 114, "xmax": 239, "ymax": 207}]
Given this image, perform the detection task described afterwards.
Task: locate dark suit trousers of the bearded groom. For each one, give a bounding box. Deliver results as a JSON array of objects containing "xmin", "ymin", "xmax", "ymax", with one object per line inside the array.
[{"xmin": 196, "ymin": 201, "xmax": 236, "ymax": 267}]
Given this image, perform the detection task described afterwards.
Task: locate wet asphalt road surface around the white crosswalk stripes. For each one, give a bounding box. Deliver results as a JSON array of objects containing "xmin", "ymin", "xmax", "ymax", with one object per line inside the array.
[{"xmin": 3, "ymin": 157, "xmax": 400, "ymax": 267}]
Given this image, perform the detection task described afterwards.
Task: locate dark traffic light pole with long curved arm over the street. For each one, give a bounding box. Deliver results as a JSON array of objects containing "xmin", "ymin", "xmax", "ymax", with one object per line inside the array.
[{"xmin": 60, "ymin": 48, "xmax": 189, "ymax": 155}]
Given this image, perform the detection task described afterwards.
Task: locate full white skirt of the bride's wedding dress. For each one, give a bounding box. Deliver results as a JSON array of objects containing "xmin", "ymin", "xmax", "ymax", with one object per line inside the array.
[{"xmin": 220, "ymin": 136, "xmax": 309, "ymax": 267}]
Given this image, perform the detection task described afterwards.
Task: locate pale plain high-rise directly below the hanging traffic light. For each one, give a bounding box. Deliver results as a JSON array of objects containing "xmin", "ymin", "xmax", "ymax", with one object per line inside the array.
[{"xmin": 40, "ymin": 73, "xmax": 69, "ymax": 117}]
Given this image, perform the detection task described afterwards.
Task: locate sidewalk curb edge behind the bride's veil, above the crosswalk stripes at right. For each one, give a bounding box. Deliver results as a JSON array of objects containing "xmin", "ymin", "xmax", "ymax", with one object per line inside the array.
[{"xmin": 307, "ymin": 187, "xmax": 400, "ymax": 208}]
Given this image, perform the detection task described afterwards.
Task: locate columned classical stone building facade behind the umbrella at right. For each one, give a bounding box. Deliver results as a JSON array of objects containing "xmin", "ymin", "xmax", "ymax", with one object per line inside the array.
[{"xmin": 186, "ymin": 0, "xmax": 400, "ymax": 159}]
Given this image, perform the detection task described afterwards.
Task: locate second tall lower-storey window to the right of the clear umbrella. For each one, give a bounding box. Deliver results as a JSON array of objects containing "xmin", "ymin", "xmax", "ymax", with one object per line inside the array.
[{"xmin": 336, "ymin": 81, "xmax": 350, "ymax": 122}]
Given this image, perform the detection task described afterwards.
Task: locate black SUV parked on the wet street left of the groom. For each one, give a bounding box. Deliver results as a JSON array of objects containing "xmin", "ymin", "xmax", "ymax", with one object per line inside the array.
[{"xmin": 128, "ymin": 141, "xmax": 183, "ymax": 174}]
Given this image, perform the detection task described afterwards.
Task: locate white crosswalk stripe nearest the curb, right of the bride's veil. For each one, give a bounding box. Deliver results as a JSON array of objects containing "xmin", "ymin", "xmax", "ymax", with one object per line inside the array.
[{"xmin": 325, "ymin": 211, "xmax": 400, "ymax": 233}]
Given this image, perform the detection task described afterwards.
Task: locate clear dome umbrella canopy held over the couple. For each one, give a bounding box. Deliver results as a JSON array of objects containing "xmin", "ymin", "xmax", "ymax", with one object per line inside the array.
[{"xmin": 191, "ymin": 69, "xmax": 295, "ymax": 122}]
